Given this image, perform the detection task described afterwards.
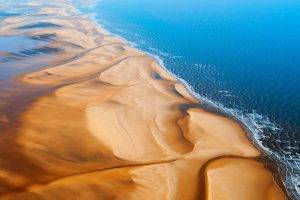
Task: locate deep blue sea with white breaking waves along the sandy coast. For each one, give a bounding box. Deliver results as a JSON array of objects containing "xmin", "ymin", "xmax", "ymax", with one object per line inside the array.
[{"xmin": 77, "ymin": 0, "xmax": 300, "ymax": 198}]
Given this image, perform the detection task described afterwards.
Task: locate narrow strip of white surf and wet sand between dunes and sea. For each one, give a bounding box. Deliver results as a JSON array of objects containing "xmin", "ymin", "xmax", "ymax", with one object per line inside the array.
[{"xmin": 75, "ymin": 3, "xmax": 294, "ymax": 199}]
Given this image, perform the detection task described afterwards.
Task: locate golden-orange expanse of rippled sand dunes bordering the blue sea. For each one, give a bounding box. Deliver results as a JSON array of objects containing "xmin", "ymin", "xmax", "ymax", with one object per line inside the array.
[{"xmin": 0, "ymin": 3, "xmax": 285, "ymax": 200}]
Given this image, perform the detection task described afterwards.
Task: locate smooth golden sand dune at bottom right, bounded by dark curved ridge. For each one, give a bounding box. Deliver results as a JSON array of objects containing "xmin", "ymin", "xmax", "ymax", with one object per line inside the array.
[{"xmin": 205, "ymin": 158, "xmax": 284, "ymax": 200}]
